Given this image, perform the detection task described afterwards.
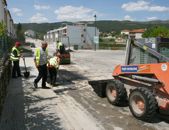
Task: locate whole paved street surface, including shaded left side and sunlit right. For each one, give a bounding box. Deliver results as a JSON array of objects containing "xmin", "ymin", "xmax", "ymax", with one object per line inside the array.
[{"xmin": 0, "ymin": 47, "xmax": 169, "ymax": 130}]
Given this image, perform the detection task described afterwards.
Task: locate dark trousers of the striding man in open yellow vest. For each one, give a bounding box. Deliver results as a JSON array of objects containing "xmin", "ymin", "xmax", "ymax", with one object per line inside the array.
[{"xmin": 34, "ymin": 64, "xmax": 47, "ymax": 87}]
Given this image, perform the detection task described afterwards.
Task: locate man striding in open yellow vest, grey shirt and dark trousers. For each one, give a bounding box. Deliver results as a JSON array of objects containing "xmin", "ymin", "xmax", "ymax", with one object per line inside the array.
[{"xmin": 34, "ymin": 42, "xmax": 48, "ymax": 88}]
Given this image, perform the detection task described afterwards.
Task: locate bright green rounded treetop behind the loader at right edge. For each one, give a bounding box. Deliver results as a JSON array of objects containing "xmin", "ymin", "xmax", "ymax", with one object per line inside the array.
[{"xmin": 143, "ymin": 26, "xmax": 169, "ymax": 38}]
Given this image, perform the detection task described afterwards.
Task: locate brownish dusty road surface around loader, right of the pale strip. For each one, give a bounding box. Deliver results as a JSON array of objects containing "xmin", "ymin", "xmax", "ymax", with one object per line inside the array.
[{"xmin": 60, "ymin": 50, "xmax": 169, "ymax": 130}]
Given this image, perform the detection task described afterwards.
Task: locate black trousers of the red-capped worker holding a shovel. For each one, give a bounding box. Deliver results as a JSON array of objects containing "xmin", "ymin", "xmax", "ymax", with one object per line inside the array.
[{"xmin": 12, "ymin": 60, "xmax": 21, "ymax": 77}]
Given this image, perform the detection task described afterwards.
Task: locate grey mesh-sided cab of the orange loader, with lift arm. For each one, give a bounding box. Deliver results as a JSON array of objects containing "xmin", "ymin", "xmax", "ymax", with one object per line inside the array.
[{"xmin": 125, "ymin": 38, "xmax": 169, "ymax": 65}]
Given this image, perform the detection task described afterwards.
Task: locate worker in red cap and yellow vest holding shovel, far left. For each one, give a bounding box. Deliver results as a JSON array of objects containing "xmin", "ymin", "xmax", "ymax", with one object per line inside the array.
[{"xmin": 10, "ymin": 42, "xmax": 22, "ymax": 78}]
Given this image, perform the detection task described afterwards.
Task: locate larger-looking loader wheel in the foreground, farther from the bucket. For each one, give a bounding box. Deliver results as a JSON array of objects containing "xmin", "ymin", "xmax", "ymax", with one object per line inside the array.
[{"xmin": 129, "ymin": 87, "xmax": 158, "ymax": 122}]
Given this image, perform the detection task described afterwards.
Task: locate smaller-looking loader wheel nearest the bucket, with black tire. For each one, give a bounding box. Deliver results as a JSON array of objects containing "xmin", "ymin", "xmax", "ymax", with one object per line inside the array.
[{"xmin": 106, "ymin": 80, "xmax": 127, "ymax": 106}]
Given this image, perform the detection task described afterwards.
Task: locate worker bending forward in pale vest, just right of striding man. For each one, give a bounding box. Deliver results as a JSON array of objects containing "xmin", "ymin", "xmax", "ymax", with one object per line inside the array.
[{"xmin": 48, "ymin": 51, "xmax": 61, "ymax": 86}]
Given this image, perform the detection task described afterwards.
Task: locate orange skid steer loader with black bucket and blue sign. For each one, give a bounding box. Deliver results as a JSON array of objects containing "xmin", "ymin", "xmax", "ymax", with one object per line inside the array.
[{"xmin": 89, "ymin": 38, "xmax": 169, "ymax": 121}]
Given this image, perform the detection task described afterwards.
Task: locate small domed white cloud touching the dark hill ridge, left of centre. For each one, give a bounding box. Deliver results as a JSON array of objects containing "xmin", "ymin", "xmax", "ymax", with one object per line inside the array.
[{"xmin": 30, "ymin": 13, "xmax": 48, "ymax": 23}]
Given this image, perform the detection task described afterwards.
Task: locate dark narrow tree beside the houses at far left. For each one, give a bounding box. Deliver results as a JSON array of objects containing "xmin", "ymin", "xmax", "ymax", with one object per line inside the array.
[{"xmin": 16, "ymin": 23, "xmax": 25, "ymax": 42}]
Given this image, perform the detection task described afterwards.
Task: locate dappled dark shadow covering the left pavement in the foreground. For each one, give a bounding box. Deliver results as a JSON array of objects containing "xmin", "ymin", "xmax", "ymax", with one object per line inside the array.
[{"xmin": 0, "ymin": 70, "xmax": 63, "ymax": 130}]
